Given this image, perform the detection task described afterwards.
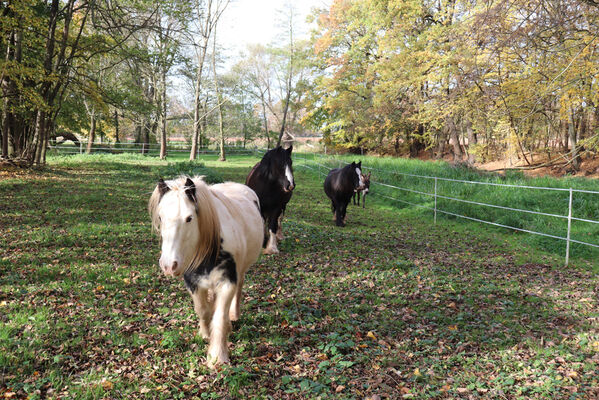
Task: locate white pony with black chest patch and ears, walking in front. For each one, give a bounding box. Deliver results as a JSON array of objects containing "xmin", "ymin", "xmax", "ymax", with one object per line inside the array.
[{"xmin": 148, "ymin": 177, "xmax": 264, "ymax": 367}]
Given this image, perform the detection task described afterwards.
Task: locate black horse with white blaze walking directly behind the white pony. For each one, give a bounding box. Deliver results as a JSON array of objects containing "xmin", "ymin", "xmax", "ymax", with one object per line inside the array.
[{"xmin": 245, "ymin": 146, "xmax": 295, "ymax": 254}]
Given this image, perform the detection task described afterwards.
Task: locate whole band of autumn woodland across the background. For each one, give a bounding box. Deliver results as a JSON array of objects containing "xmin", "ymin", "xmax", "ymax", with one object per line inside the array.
[{"xmin": 0, "ymin": 0, "xmax": 599, "ymax": 171}]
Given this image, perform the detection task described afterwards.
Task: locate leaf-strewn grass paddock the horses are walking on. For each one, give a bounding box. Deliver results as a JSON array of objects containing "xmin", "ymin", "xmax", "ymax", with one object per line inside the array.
[{"xmin": 0, "ymin": 152, "xmax": 599, "ymax": 399}]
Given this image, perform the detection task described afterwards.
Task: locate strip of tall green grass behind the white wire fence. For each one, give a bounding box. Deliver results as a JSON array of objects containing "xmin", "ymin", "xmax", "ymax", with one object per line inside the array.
[{"xmin": 296, "ymin": 154, "xmax": 599, "ymax": 262}]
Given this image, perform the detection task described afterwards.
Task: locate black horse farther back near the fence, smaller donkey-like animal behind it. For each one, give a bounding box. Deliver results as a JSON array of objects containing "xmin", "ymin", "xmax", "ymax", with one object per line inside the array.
[{"xmin": 324, "ymin": 161, "xmax": 364, "ymax": 226}]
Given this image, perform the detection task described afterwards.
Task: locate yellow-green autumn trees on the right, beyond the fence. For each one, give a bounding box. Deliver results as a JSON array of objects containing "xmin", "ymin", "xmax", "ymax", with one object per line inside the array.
[{"xmin": 305, "ymin": 0, "xmax": 599, "ymax": 161}]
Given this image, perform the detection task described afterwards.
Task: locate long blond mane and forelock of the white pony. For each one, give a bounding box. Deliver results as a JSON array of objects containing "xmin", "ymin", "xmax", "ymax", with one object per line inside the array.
[{"xmin": 148, "ymin": 176, "xmax": 223, "ymax": 267}]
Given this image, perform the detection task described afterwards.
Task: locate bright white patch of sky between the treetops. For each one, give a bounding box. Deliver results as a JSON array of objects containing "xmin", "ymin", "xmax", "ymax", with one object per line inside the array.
[{"xmin": 217, "ymin": 0, "xmax": 332, "ymax": 57}]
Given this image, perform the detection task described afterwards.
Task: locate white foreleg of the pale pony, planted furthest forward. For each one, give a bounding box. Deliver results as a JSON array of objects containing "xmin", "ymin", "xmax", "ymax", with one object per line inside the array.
[{"xmin": 206, "ymin": 280, "xmax": 237, "ymax": 367}]
